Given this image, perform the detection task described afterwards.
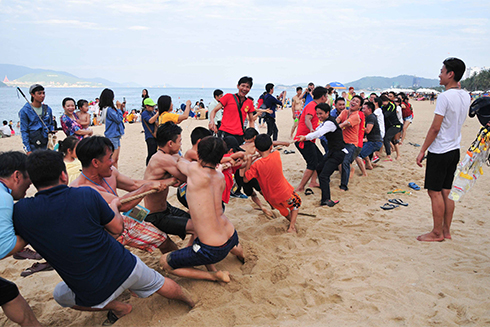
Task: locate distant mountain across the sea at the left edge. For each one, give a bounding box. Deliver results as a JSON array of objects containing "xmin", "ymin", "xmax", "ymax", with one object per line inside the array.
[{"xmin": 0, "ymin": 64, "xmax": 139, "ymax": 87}]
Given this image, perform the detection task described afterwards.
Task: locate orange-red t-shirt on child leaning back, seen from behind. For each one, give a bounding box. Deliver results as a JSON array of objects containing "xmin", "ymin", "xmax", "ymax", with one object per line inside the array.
[{"xmin": 245, "ymin": 151, "xmax": 294, "ymax": 206}]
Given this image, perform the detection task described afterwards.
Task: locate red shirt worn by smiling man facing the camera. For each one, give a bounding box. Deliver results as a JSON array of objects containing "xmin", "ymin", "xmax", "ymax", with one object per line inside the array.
[{"xmin": 219, "ymin": 93, "xmax": 255, "ymax": 135}]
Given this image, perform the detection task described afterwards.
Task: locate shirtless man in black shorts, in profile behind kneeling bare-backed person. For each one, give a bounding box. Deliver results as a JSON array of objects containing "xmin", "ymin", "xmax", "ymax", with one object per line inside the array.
[{"xmin": 144, "ymin": 121, "xmax": 194, "ymax": 242}]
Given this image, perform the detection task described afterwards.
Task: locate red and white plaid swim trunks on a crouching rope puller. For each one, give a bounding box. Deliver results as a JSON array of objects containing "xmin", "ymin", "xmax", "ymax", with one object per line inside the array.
[{"xmin": 117, "ymin": 216, "xmax": 167, "ymax": 253}]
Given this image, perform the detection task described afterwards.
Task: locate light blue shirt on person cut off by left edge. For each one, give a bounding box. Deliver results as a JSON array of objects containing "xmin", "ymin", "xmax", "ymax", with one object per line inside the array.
[{"xmin": 0, "ymin": 183, "xmax": 17, "ymax": 259}]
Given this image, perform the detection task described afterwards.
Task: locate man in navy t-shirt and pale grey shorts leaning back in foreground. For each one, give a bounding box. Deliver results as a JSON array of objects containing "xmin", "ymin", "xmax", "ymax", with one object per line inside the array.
[{"xmin": 13, "ymin": 150, "xmax": 194, "ymax": 324}]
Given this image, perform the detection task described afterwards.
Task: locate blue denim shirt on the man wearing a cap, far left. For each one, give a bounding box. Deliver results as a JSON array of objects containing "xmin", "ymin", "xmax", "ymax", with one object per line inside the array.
[{"xmin": 19, "ymin": 103, "xmax": 54, "ymax": 152}]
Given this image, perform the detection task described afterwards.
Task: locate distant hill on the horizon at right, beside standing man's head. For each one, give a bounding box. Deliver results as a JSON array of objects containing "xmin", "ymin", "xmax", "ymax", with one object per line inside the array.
[{"xmin": 344, "ymin": 75, "xmax": 439, "ymax": 90}]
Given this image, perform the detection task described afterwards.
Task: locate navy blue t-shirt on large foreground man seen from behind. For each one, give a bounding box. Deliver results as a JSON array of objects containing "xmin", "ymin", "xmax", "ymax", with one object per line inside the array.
[{"xmin": 14, "ymin": 185, "xmax": 136, "ymax": 307}]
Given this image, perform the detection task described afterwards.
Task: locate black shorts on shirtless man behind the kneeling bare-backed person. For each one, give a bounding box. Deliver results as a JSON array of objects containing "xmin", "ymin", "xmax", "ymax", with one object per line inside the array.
[{"xmin": 145, "ymin": 202, "xmax": 191, "ymax": 239}]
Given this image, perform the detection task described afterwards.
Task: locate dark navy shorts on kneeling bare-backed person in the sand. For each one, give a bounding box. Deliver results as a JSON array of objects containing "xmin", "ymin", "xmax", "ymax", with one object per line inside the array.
[{"xmin": 167, "ymin": 230, "xmax": 238, "ymax": 269}]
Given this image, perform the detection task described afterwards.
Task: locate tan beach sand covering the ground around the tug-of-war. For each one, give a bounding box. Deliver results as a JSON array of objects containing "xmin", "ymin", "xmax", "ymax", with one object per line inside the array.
[{"xmin": 0, "ymin": 102, "xmax": 490, "ymax": 326}]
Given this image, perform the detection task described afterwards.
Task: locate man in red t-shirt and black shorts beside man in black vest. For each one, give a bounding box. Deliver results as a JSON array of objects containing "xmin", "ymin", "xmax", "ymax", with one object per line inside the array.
[{"xmin": 294, "ymin": 86, "xmax": 327, "ymax": 192}]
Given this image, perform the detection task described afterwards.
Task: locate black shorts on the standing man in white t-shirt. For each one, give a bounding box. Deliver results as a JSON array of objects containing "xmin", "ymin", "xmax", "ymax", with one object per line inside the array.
[{"xmin": 424, "ymin": 149, "xmax": 459, "ymax": 192}]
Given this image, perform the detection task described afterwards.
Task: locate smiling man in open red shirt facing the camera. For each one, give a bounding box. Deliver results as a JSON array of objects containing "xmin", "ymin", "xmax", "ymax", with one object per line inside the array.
[{"xmin": 209, "ymin": 76, "xmax": 255, "ymax": 144}]
